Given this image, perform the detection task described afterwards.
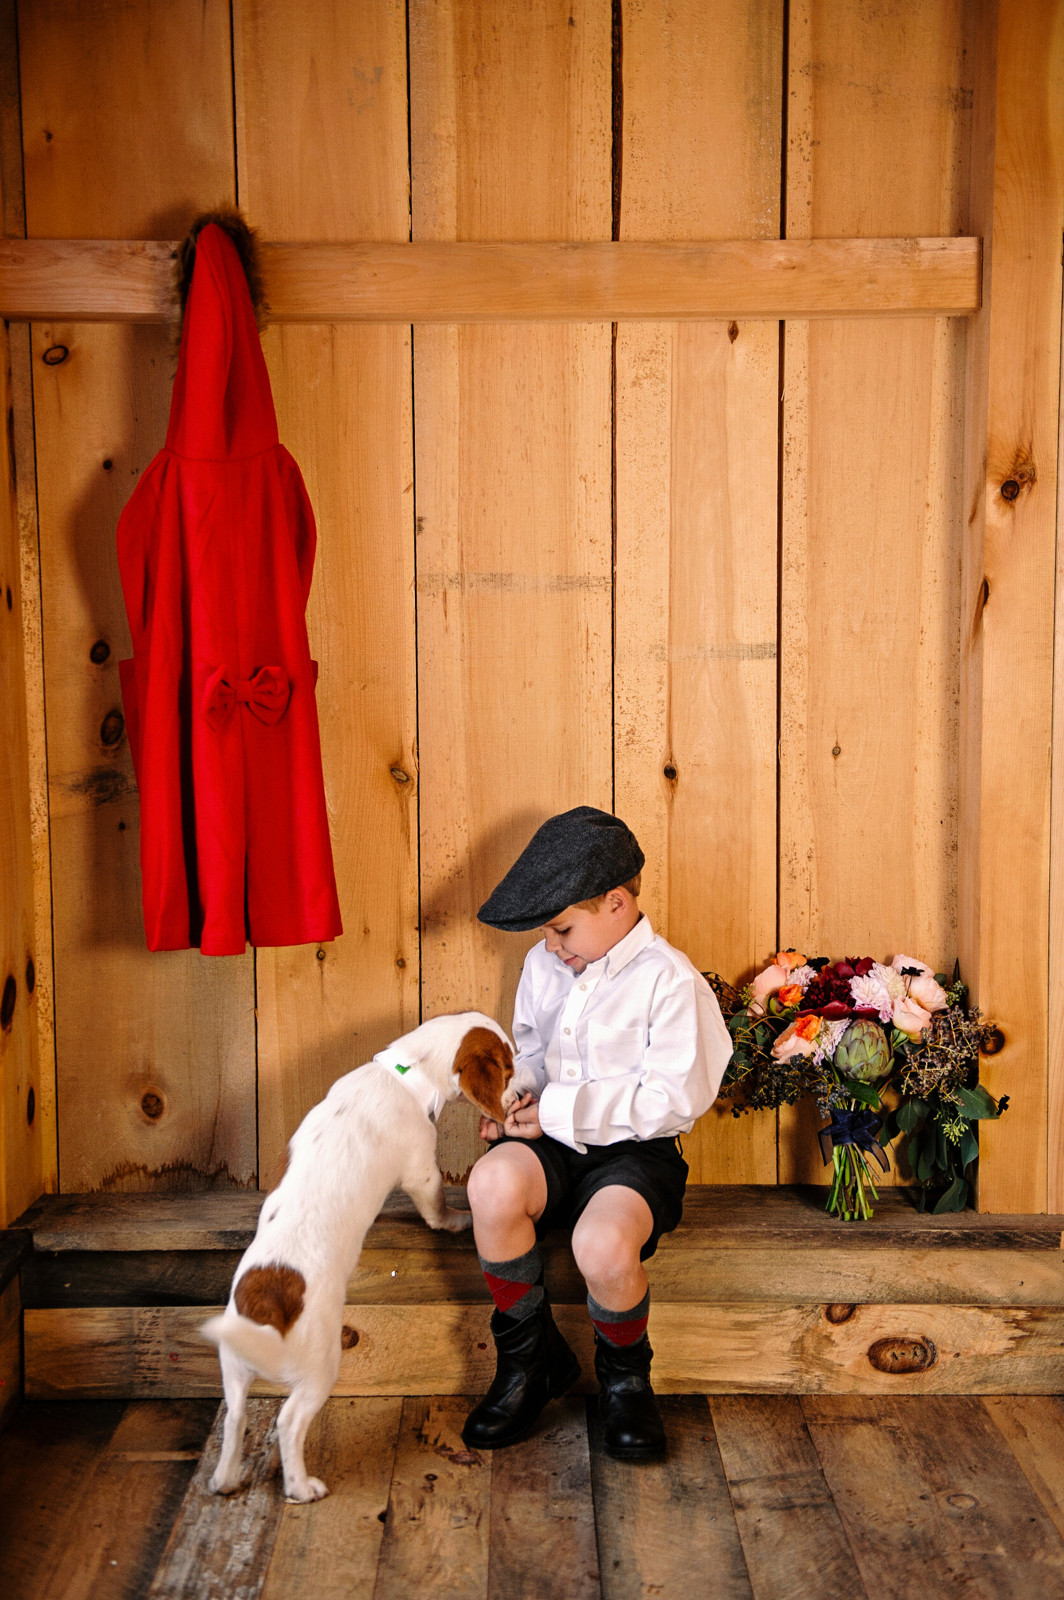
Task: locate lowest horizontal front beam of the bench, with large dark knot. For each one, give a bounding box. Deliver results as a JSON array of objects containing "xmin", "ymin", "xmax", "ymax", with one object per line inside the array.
[{"xmin": 26, "ymin": 1299, "xmax": 1064, "ymax": 1400}]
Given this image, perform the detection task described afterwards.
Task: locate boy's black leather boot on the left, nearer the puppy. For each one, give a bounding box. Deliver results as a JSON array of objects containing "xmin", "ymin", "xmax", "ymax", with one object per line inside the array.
[{"xmin": 462, "ymin": 1293, "xmax": 581, "ymax": 1450}]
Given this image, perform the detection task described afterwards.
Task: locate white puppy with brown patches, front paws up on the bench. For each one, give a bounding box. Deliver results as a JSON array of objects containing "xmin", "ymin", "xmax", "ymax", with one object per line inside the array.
[{"xmin": 202, "ymin": 1011, "xmax": 518, "ymax": 1501}]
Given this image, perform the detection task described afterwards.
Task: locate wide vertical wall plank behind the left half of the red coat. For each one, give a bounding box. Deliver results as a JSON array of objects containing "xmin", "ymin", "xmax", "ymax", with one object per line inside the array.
[{"xmin": 19, "ymin": 0, "xmax": 254, "ymax": 1190}]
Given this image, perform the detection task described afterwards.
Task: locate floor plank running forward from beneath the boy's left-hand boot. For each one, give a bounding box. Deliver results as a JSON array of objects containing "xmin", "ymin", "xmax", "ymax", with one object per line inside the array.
[{"xmin": 488, "ymin": 1395, "xmax": 602, "ymax": 1600}]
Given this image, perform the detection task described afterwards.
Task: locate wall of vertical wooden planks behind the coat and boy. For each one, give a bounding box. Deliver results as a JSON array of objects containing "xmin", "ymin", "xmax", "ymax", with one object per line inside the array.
[{"xmin": 5, "ymin": 0, "xmax": 1064, "ymax": 1211}]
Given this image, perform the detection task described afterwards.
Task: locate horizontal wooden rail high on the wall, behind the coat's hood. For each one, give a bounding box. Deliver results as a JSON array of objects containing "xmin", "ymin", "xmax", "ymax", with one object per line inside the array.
[{"xmin": 0, "ymin": 238, "xmax": 981, "ymax": 323}]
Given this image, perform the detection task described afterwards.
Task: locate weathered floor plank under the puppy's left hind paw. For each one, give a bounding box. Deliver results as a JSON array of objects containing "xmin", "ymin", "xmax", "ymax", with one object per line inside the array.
[{"xmin": 147, "ymin": 1400, "xmax": 285, "ymax": 1600}]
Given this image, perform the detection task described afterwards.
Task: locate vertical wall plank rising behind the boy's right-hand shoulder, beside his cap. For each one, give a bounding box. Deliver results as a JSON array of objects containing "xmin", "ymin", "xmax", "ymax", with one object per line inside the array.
[{"xmin": 614, "ymin": 0, "xmax": 784, "ymax": 1182}]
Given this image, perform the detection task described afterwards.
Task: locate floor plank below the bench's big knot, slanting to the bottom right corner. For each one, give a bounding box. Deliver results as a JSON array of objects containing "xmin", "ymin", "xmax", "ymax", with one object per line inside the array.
[{"xmin": 893, "ymin": 1395, "xmax": 1064, "ymax": 1600}]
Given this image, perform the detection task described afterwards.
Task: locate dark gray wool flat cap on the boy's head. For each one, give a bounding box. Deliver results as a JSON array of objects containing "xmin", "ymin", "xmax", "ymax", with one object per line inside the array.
[{"xmin": 477, "ymin": 805, "xmax": 646, "ymax": 933}]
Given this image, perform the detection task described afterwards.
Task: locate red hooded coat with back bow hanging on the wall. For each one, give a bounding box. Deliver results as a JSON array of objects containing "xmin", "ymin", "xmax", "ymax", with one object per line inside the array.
[{"xmin": 118, "ymin": 224, "xmax": 342, "ymax": 955}]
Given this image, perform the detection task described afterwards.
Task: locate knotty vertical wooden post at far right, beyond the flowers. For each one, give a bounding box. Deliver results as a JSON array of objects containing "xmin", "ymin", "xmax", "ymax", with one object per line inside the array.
[{"xmin": 960, "ymin": 0, "xmax": 1064, "ymax": 1211}]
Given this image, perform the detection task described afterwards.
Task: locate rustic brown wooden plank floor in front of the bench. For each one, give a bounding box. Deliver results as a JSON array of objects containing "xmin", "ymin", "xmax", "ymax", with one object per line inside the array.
[{"xmin": 0, "ymin": 1395, "xmax": 1064, "ymax": 1600}]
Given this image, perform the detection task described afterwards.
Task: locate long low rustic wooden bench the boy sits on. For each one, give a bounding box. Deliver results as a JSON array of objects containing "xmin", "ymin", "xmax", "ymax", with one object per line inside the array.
[{"xmin": 16, "ymin": 1187, "xmax": 1064, "ymax": 1398}]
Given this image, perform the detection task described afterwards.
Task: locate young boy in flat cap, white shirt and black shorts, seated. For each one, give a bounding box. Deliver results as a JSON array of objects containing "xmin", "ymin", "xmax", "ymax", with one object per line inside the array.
[{"xmin": 462, "ymin": 806, "xmax": 731, "ymax": 1461}]
